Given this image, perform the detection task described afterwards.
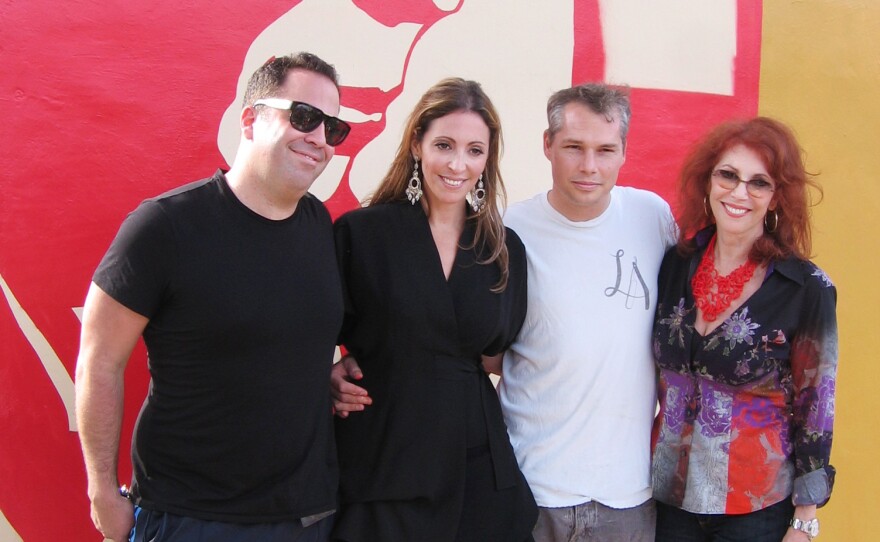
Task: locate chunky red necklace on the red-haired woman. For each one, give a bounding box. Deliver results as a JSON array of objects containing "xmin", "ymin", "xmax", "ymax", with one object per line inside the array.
[{"xmin": 691, "ymin": 235, "xmax": 758, "ymax": 322}]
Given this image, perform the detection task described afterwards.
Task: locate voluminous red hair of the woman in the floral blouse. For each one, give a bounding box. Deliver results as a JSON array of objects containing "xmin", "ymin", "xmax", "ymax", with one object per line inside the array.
[{"xmin": 676, "ymin": 117, "xmax": 822, "ymax": 263}]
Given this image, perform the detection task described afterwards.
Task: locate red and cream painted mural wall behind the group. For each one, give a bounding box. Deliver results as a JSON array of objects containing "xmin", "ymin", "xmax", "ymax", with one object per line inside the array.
[{"xmin": 0, "ymin": 0, "xmax": 762, "ymax": 541}]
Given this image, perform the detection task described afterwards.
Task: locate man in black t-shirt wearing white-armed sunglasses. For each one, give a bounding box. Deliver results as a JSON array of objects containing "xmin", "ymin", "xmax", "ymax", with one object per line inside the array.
[{"xmin": 76, "ymin": 53, "xmax": 349, "ymax": 542}]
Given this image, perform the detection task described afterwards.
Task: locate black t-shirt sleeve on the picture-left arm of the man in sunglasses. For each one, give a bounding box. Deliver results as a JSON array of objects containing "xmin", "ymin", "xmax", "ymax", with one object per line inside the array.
[{"xmin": 92, "ymin": 201, "xmax": 176, "ymax": 318}]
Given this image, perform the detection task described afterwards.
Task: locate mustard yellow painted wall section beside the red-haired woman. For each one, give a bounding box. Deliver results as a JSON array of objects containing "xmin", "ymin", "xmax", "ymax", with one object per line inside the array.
[{"xmin": 759, "ymin": 0, "xmax": 880, "ymax": 542}]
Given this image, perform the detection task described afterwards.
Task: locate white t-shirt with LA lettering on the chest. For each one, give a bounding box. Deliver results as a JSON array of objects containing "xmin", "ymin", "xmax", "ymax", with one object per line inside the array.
[{"xmin": 499, "ymin": 187, "xmax": 674, "ymax": 508}]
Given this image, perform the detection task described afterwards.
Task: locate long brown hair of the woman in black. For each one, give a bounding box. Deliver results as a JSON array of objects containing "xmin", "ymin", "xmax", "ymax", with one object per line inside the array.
[{"xmin": 366, "ymin": 77, "xmax": 509, "ymax": 293}]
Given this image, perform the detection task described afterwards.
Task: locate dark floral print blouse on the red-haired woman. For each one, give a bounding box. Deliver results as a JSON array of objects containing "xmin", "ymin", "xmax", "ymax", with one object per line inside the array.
[{"xmin": 652, "ymin": 231, "xmax": 837, "ymax": 514}]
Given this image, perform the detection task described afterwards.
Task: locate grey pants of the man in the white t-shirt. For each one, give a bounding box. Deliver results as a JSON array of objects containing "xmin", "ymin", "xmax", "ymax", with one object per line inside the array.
[{"xmin": 534, "ymin": 499, "xmax": 652, "ymax": 542}]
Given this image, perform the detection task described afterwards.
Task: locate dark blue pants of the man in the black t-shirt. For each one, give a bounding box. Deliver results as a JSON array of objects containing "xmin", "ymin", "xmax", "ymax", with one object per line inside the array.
[{"xmin": 129, "ymin": 507, "xmax": 335, "ymax": 542}]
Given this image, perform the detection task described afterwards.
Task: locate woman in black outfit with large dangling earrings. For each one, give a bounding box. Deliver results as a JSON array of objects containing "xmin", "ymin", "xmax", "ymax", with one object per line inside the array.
[{"xmin": 333, "ymin": 79, "xmax": 537, "ymax": 542}]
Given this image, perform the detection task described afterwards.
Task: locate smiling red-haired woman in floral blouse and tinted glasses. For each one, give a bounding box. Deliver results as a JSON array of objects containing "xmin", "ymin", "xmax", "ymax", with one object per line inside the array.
[{"xmin": 652, "ymin": 117, "xmax": 837, "ymax": 542}]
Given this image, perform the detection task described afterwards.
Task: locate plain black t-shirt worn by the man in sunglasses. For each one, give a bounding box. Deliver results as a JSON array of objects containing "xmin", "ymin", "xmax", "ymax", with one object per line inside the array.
[{"xmin": 94, "ymin": 172, "xmax": 343, "ymax": 522}]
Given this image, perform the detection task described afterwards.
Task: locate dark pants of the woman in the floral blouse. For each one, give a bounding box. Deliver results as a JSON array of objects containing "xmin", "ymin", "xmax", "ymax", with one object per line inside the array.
[{"xmin": 657, "ymin": 499, "xmax": 794, "ymax": 542}]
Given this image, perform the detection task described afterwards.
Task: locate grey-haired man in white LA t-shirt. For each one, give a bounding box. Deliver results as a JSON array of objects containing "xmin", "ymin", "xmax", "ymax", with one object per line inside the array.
[{"xmin": 494, "ymin": 84, "xmax": 674, "ymax": 542}]
